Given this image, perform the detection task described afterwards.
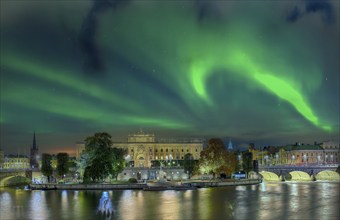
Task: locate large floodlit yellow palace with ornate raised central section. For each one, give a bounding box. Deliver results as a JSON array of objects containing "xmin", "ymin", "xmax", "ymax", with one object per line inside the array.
[{"xmin": 76, "ymin": 131, "xmax": 204, "ymax": 167}]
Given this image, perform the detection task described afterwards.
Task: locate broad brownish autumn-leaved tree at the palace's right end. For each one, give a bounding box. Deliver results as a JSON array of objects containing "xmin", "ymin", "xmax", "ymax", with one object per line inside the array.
[{"xmin": 199, "ymin": 138, "xmax": 237, "ymax": 178}]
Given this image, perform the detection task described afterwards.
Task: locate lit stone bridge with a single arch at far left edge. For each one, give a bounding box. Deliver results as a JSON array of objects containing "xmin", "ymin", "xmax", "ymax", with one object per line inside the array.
[{"xmin": 0, "ymin": 169, "xmax": 32, "ymax": 187}]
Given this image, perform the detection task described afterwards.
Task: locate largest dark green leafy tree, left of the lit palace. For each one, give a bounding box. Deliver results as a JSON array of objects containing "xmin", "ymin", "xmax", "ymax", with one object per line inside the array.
[{"xmin": 82, "ymin": 132, "xmax": 125, "ymax": 182}]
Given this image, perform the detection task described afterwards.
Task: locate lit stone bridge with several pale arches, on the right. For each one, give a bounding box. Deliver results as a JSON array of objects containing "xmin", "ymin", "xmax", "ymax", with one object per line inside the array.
[{"xmin": 259, "ymin": 164, "xmax": 340, "ymax": 181}]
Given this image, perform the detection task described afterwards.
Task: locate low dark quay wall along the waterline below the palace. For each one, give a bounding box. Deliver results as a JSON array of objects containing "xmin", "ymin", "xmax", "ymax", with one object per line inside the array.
[{"xmin": 30, "ymin": 179, "xmax": 261, "ymax": 190}]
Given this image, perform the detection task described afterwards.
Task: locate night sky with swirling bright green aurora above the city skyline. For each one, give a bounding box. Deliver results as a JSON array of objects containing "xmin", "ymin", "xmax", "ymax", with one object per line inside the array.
[{"xmin": 0, "ymin": 0, "xmax": 340, "ymax": 154}]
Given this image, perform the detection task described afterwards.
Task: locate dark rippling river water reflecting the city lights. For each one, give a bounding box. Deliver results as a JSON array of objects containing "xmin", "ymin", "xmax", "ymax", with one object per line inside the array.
[{"xmin": 0, "ymin": 182, "xmax": 340, "ymax": 220}]
